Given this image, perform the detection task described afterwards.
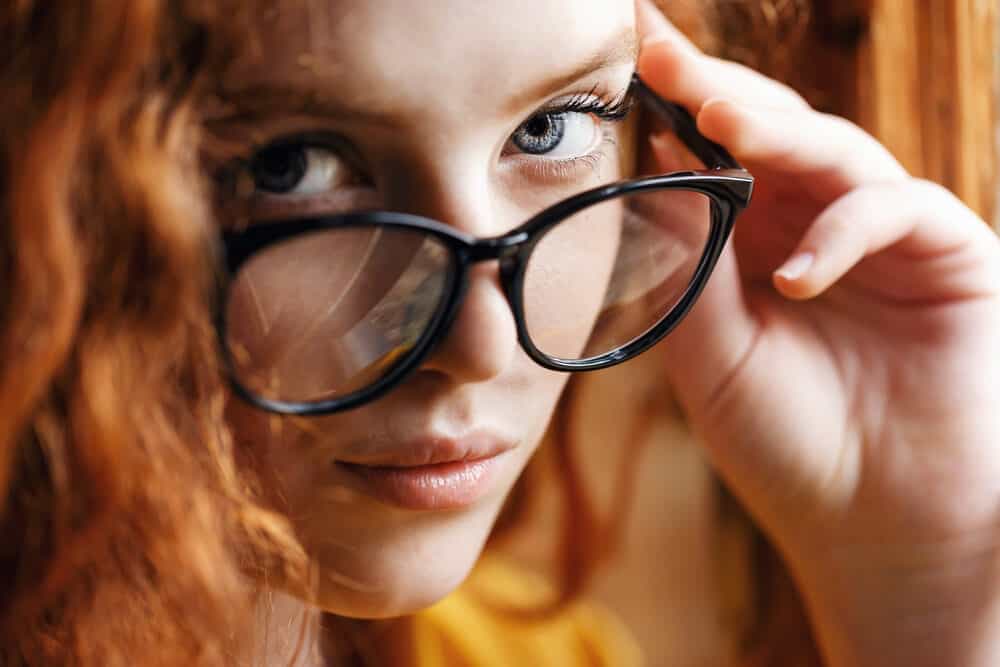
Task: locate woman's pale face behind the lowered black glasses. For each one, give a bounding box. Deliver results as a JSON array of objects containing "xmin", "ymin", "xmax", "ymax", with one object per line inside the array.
[{"xmin": 211, "ymin": 0, "xmax": 636, "ymax": 617}]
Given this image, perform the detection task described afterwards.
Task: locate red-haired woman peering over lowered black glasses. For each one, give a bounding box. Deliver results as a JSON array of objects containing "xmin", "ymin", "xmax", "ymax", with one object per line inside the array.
[{"xmin": 2, "ymin": 0, "xmax": 1000, "ymax": 665}]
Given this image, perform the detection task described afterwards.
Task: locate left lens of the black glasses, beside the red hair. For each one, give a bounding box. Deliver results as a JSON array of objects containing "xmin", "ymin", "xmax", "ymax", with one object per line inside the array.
[{"xmin": 226, "ymin": 227, "xmax": 454, "ymax": 402}]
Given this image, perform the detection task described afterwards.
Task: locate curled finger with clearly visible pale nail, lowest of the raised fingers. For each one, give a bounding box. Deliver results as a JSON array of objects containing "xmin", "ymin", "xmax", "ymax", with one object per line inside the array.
[{"xmin": 773, "ymin": 179, "xmax": 998, "ymax": 301}]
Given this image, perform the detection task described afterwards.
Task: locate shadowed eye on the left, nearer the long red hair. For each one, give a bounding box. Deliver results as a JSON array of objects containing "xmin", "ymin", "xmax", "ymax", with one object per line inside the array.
[{"xmin": 249, "ymin": 143, "xmax": 354, "ymax": 195}]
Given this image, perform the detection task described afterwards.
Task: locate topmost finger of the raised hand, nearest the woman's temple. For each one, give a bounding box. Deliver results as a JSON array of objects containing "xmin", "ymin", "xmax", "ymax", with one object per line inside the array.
[{"xmin": 638, "ymin": 16, "xmax": 808, "ymax": 113}]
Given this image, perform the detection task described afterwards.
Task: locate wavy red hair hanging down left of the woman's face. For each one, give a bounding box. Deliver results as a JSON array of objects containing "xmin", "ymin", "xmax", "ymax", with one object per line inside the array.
[{"xmin": 0, "ymin": 0, "xmax": 302, "ymax": 666}]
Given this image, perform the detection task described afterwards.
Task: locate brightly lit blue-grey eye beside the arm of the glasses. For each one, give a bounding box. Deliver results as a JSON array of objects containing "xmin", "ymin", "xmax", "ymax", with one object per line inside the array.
[{"xmin": 510, "ymin": 111, "xmax": 602, "ymax": 160}]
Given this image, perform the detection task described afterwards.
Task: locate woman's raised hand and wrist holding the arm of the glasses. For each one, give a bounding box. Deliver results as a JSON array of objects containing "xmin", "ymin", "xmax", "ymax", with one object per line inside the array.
[{"xmin": 640, "ymin": 2, "xmax": 1000, "ymax": 667}]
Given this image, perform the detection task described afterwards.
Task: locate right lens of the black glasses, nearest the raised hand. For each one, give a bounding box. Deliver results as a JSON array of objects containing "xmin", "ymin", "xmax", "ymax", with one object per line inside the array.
[{"xmin": 523, "ymin": 190, "xmax": 712, "ymax": 360}]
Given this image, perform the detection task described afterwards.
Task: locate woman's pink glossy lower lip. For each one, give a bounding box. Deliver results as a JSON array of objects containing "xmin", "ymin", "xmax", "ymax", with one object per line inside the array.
[{"xmin": 340, "ymin": 452, "xmax": 508, "ymax": 511}]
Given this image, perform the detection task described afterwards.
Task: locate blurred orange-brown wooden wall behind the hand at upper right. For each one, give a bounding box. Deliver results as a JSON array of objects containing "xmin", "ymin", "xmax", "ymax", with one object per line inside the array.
[{"xmin": 793, "ymin": 0, "xmax": 998, "ymax": 222}]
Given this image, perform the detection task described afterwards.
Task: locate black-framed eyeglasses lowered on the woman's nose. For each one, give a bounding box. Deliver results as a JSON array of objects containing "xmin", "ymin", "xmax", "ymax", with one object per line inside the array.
[{"xmin": 217, "ymin": 77, "xmax": 753, "ymax": 415}]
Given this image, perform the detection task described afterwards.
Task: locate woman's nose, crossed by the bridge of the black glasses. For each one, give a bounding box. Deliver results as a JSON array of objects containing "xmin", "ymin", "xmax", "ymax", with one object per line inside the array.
[{"xmin": 393, "ymin": 172, "xmax": 518, "ymax": 383}]
